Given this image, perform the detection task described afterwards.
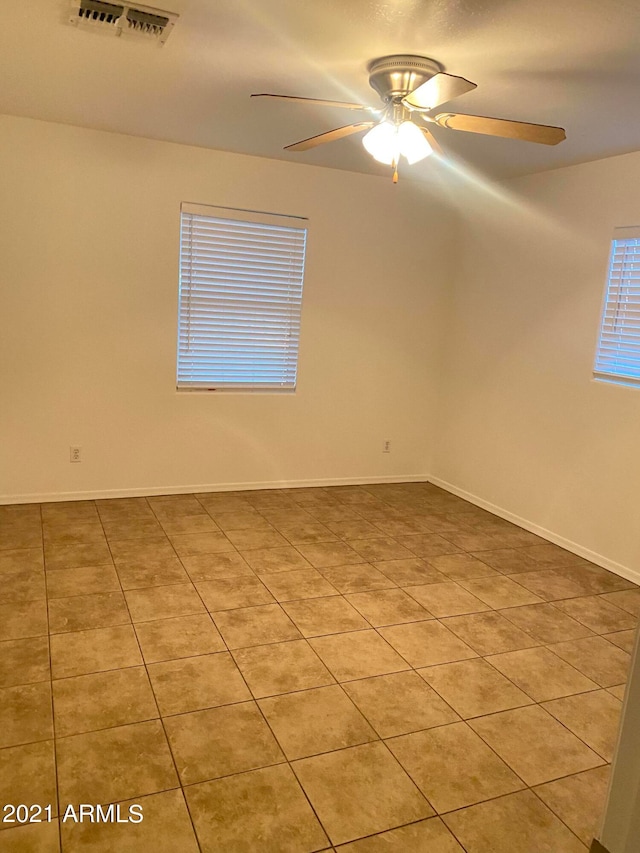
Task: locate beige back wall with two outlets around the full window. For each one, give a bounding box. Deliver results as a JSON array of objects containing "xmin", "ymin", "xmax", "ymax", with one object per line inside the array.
[{"xmin": 0, "ymin": 116, "xmax": 451, "ymax": 502}]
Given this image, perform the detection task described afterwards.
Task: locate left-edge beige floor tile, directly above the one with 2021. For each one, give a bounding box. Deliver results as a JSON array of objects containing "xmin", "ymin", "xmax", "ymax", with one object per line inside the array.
[{"xmin": 0, "ymin": 681, "xmax": 53, "ymax": 748}]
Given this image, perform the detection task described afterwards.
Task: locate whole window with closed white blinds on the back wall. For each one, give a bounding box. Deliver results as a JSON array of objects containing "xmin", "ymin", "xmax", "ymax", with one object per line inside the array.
[{"xmin": 178, "ymin": 204, "xmax": 307, "ymax": 391}]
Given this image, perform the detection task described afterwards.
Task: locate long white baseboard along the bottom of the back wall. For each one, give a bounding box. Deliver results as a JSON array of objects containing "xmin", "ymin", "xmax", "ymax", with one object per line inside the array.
[{"xmin": 0, "ymin": 474, "xmax": 429, "ymax": 506}]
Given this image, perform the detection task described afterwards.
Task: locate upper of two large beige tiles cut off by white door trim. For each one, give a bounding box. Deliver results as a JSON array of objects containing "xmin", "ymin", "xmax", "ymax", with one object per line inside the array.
[{"xmin": 543, "ymin": 690, "xmax": 622, "ymax": 761}]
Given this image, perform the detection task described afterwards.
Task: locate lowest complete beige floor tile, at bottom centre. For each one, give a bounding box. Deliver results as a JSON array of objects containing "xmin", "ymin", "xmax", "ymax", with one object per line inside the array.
[{"xmin": 293, "ymin": 743, "xmax": 433, "ymax": 844}]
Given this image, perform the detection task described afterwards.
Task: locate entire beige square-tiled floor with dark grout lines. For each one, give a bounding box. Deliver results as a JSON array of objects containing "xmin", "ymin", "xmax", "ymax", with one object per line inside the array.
[{"xmin": 0, "ymin": 483, "xmax": 640, "ymax": 853}]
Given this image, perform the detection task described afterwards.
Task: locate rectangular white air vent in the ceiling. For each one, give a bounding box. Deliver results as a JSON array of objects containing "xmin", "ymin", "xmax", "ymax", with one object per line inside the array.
[{"xmin": 69, "ymin": 0, "xmax": 178, "ymax": 44}]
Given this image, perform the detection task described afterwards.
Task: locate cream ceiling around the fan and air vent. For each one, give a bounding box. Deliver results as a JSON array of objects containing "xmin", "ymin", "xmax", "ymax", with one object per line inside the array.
[{"xmin": 0, "ymin": 0, "xmax": 640, "ymax": 178}]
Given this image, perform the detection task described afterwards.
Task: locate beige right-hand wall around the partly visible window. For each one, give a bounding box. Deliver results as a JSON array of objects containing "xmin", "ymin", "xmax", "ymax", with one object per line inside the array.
[{"xmin": 432, "ymin": 154, "xmax": 640, "ymax": 579}]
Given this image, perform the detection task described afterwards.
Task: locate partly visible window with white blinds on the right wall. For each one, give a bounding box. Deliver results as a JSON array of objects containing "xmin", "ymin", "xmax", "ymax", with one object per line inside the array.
[{"xmin": 594, "ymin": 227, "xmax": 640, "ymax": 385}]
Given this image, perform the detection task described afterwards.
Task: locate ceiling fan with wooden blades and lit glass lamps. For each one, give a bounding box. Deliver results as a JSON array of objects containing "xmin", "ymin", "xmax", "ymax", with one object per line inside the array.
[{"xmin": 251, "ymin": 54, "xmax": 566, "ymax": 183}]
